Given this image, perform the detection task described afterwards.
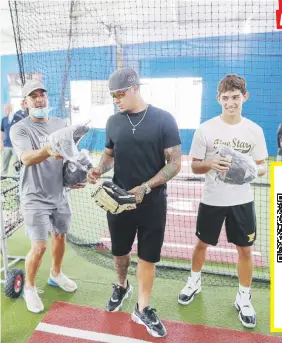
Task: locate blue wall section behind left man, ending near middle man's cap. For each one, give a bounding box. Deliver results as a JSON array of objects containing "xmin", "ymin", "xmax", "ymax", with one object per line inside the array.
[{"xmin": 1, "ymin": 47, "xmax": 116, "ymax": 118}]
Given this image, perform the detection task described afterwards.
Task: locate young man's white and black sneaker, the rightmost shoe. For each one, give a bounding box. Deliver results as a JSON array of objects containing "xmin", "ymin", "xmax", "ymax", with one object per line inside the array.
[{"xmin": 234, "ymin": 291, "xmax": 256, "ymax": 328}]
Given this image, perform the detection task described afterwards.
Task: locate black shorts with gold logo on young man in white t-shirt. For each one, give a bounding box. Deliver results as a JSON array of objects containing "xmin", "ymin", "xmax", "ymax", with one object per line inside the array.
[{"xmin": 196, "ymin": 201, "xmax": 256, "ymax": 247}]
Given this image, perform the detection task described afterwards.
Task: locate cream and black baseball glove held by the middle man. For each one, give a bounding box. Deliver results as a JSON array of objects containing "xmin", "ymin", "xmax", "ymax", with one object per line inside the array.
[{"xmin": 91, "ymin": 181, "xmax": 136, "ymax": 214}]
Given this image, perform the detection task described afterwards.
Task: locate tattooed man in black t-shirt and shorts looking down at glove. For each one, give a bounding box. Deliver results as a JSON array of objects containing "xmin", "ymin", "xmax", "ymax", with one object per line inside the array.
[{"xmin": 88, "ymin": 68, "xmax": 181, "ymax": 337}]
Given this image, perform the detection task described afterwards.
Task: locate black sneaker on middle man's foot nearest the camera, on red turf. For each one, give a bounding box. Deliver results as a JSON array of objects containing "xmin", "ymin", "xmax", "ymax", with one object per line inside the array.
[{"xmin": 131, "ymin": 304, "xmax": 167, "ymax": 337}]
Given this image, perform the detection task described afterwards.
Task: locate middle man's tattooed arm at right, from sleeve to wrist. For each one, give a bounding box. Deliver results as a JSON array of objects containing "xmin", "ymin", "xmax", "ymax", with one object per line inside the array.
[{"xmin": 148, "ymin": 145, "xmax": 181, "ymax": 188}]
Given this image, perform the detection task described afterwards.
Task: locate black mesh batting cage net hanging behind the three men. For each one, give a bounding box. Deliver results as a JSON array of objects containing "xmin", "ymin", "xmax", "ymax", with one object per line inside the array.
[{"xmin": 7, "ymin": 0, "xmax": 282, "ymax": 285}]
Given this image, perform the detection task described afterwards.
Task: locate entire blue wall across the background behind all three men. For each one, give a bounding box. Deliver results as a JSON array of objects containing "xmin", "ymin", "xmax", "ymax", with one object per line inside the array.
[{"xmin": 1, "ymin": 32, "xmax": 282, "ymax": 155}]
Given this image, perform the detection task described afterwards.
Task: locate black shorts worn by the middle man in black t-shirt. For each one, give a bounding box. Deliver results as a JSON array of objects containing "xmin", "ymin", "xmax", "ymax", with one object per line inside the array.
[{"xmin": 107, "ymin": 194, "xmax": 167, "ymax": 263}]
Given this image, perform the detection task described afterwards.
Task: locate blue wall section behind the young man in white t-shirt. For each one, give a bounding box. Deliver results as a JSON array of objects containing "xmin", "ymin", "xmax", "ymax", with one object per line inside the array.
[{"xmin": 127, "ymin": 32, "xmax": 282, "ymax": 155}]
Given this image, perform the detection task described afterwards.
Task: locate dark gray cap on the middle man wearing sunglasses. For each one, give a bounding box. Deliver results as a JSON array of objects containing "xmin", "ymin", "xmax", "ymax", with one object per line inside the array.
[{"xmin": 109, "ymin": 68, "xmax": 140, "ymax": 92}]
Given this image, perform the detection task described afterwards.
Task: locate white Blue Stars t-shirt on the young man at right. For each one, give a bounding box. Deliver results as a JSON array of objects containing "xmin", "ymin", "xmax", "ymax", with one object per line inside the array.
[{"xmin": 190, "ymin": 116, "xmax": 268, "ymax": 206}]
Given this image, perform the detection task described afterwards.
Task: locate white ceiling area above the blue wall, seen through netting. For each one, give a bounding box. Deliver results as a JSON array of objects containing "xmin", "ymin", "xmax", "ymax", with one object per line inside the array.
[{"xmin": 0, "ymin": 0, "xmax": 278, "ymax": 54}]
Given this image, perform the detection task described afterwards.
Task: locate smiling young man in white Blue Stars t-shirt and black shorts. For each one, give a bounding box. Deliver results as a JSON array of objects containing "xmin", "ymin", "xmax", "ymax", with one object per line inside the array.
[{"xmin": 178, "ymin": 75, "xmax": 268, "ymax": 328}]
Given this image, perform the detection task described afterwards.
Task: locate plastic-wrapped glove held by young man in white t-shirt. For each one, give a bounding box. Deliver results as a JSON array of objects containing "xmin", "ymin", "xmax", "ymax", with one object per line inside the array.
[{"xmin": 217, "ymin": 146, "xmax": 257, "ymax": 185}]
